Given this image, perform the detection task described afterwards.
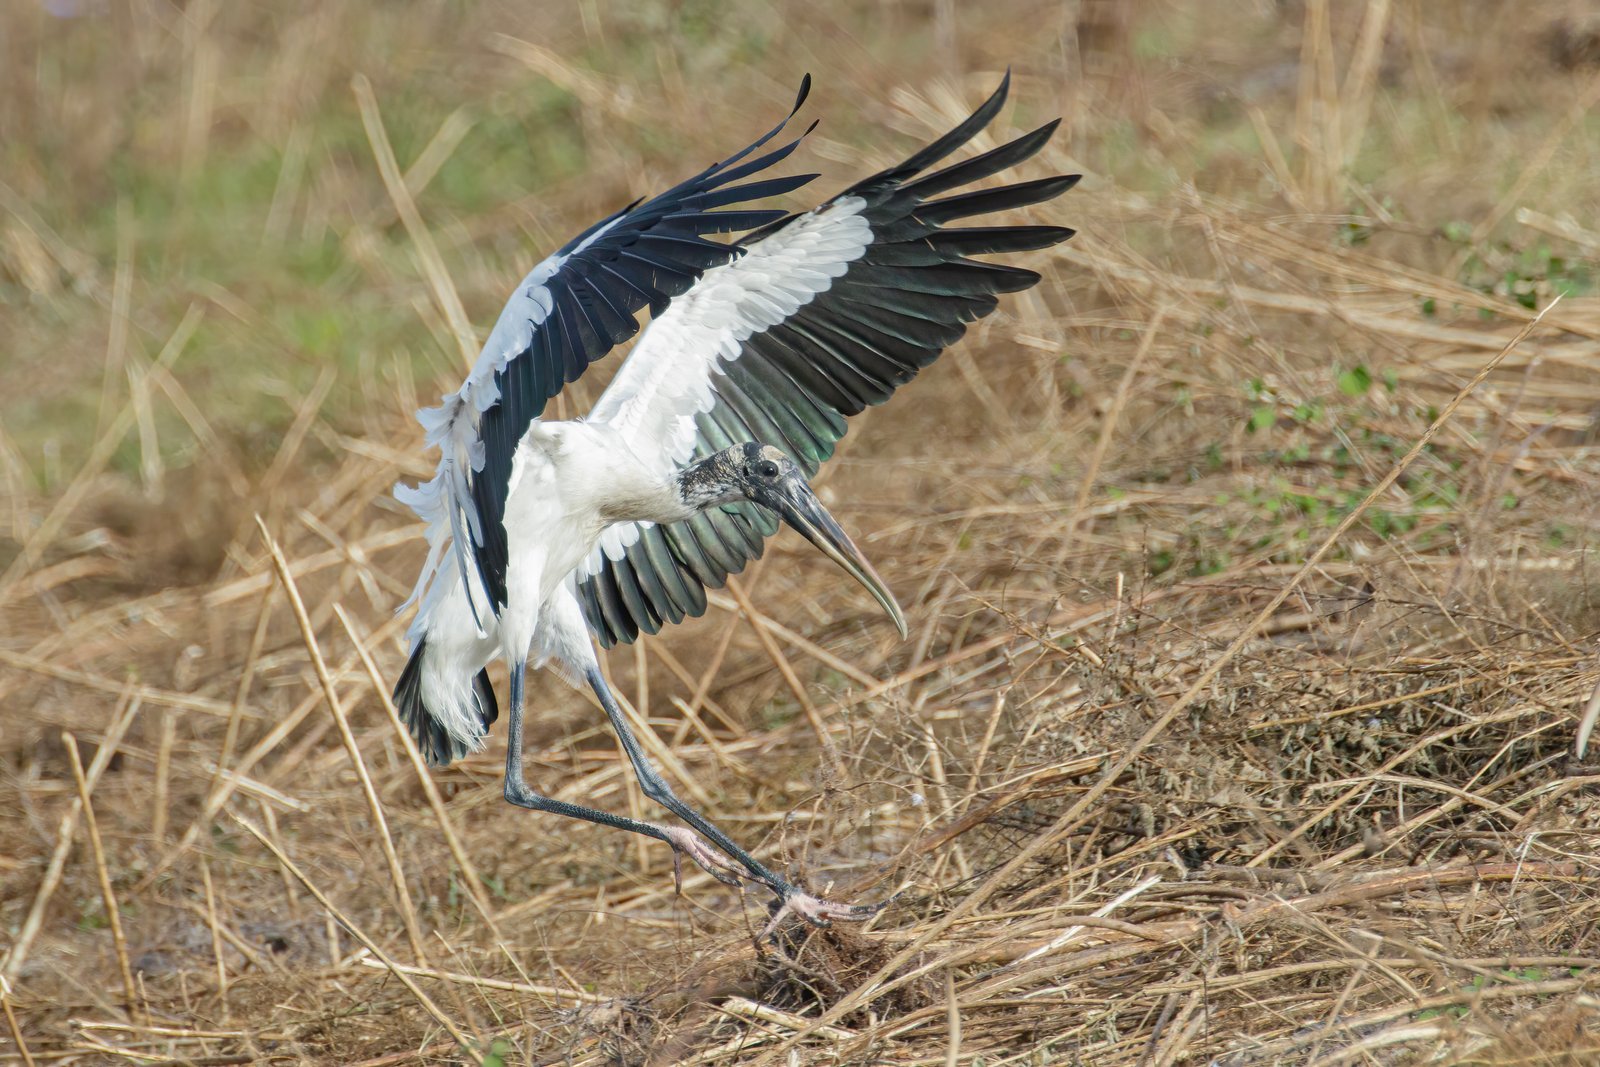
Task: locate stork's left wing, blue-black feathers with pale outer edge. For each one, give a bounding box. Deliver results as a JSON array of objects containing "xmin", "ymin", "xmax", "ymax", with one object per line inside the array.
[{"xmin": 395, "ymin": 83, "xmax": 816, "ymax": 625}]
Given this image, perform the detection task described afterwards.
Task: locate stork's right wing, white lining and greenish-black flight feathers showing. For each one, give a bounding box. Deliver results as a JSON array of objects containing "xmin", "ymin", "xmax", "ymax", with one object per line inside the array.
[{"xmin": 574, "ymin": 75, "xmax": 1078, "ymax": 646}]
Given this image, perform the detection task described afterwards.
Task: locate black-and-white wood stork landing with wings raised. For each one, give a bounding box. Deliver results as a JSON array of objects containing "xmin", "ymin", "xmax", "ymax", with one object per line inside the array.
[{"xmin": 395, "ymin": 74, "xmax": 1078, "ymax": 925}]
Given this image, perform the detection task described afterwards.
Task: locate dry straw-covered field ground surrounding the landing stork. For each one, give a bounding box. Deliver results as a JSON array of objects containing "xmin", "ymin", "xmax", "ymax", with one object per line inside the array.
[{"xmin": 0, "ymin": 0, "xmax": 1600, "ymax": 1067}]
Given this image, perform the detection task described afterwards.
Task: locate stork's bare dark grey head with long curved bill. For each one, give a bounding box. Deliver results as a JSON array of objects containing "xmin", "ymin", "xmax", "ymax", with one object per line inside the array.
[{"xmin": 678, "ymin": 442, "xmax": 907, "ymax": 638}]
